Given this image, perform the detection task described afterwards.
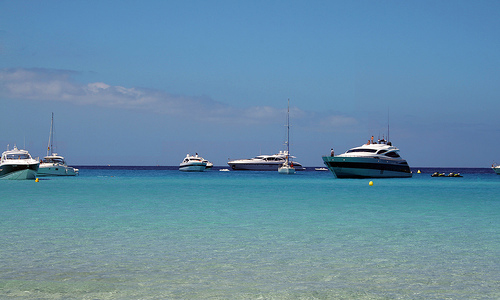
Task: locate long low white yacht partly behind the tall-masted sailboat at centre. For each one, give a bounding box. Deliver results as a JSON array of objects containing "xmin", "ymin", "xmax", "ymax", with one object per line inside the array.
[{"xmin": 227, "ymin": 151, "xmax": 305, "ymax": 171}]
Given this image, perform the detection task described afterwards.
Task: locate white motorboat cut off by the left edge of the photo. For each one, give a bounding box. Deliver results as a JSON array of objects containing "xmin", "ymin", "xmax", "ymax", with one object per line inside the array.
[{"xmin": 0, "ymin": 146, "xmax": 40, "ymax": 180}]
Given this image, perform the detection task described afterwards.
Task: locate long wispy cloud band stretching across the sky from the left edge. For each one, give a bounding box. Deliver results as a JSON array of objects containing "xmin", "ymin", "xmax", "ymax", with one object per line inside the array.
[{"xmin": 0, "ymin": 68, "xmax": 356, "ymax": 126}]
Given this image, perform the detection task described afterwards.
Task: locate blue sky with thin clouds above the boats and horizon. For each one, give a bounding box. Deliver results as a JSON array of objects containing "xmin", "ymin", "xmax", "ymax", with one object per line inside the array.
[{"xmin": 0, "ymin": 0, "xmax": 500, "ymax": 168}]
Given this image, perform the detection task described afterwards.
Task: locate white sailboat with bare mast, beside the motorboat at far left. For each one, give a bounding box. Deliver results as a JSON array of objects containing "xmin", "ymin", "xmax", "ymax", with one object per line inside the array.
[{"xmin": 37, "ymin": 113, "xmax": 78, "ymax": 177}]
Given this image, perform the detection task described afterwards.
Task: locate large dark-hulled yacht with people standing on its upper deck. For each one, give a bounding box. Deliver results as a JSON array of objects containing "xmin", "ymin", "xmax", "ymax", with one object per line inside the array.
[{"xmin": 323, "ymin": 139, "xmax": 412, "ymax": 178}]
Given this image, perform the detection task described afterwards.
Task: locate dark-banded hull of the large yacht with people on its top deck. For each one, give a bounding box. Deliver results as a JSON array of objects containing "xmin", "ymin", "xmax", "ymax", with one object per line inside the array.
[{"xmin": 323, "ymin": 156, "xmax": 412, "ymax": 178}]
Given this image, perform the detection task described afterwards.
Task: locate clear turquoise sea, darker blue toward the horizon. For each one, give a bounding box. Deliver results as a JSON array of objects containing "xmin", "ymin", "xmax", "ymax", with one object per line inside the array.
[{"xmin": 0, "ymin": 166, "xmax": 500, "ymax": 300}]
